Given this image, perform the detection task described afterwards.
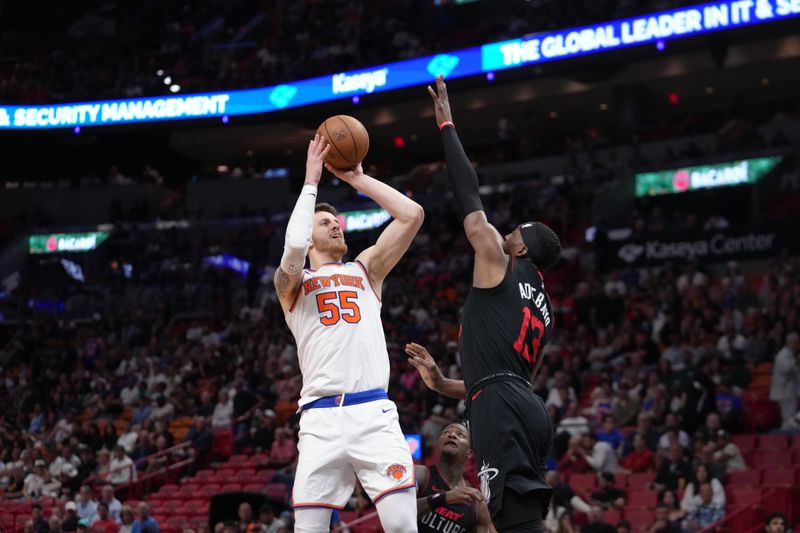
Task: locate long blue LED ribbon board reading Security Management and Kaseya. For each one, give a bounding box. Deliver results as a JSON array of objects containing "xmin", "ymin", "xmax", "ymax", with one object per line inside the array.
[{"xmin": 0, "ymin": 0, "xmax": 800, "ymax": 129}]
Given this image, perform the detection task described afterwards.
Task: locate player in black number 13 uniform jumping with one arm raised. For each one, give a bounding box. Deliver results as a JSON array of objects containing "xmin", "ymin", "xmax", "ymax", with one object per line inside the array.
[{"xmin": 428, "ymin": 76, "xmax": 561, "ymax": 532}]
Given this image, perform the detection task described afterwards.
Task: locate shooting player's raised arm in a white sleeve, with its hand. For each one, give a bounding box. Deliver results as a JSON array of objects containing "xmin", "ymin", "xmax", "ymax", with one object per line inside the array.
[{"xmin": 274, "ymin": 135, "xmax": 330, "ymax": 313}]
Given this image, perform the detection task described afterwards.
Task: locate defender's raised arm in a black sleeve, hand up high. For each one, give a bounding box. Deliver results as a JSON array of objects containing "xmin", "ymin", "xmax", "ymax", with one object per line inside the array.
[{"xmin": 428, "ymin": 75, "xmax": 508, "ymax": 288}]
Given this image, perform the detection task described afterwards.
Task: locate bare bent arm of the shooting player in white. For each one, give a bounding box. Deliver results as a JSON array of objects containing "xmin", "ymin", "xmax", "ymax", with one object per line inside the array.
[{"xmin": 325, "ymin": 164, "xmax": 425, "ymax": 296}]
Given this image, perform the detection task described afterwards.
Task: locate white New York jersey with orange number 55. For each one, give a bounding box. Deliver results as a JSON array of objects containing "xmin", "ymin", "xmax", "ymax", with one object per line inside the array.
[{"xmin": 286, "ymin": 261, "xmax": 389, "ymax": 406}]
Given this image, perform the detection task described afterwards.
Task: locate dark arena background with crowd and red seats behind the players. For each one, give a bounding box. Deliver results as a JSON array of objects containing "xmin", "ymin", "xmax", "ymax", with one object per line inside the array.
[{"xmin": 0, "ymin": 0, "xmax": 800, "ymax": 533}]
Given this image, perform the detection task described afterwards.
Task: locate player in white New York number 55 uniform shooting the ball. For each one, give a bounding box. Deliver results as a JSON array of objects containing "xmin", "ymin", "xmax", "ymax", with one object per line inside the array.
[{"xmin": 275, "ymin": 136, "xmax": 424, "ymax": 533}]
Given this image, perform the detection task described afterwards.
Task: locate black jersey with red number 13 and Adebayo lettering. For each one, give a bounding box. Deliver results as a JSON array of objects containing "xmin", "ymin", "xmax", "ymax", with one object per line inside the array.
[{"xmin": 459, "ymin": 257, "xmax": 554, "ymax": 390}]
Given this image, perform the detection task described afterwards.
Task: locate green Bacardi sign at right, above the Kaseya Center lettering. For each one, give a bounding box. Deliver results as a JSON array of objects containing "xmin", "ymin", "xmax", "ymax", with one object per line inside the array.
[{"xmin": 636, "ymin": 156, "xmax": 781, "ymax": 198}]
